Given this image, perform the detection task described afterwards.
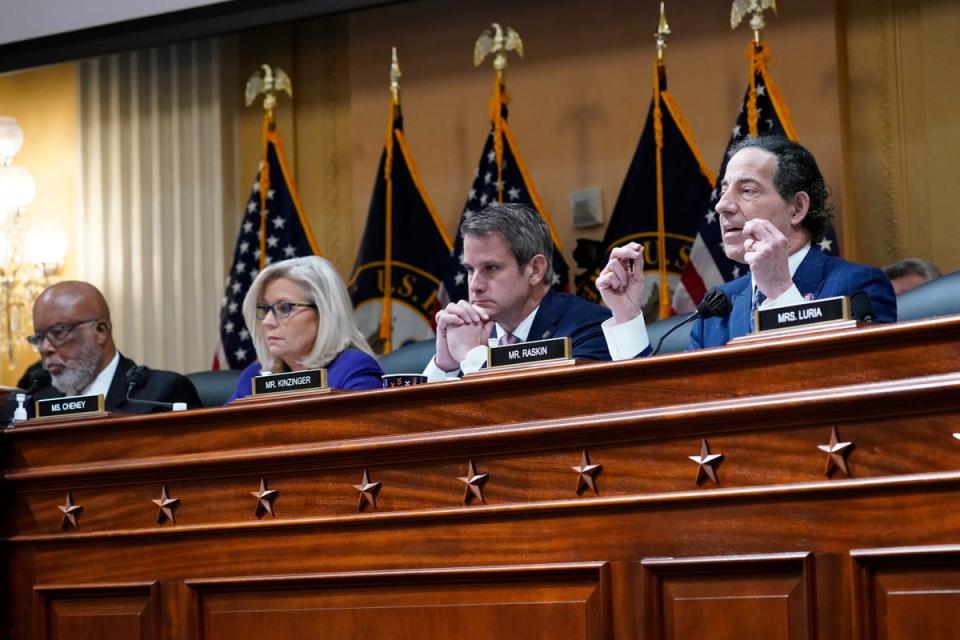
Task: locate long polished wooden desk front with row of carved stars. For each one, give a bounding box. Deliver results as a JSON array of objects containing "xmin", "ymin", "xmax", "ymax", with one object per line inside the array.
[{"xmin": 0, "ymin": 319, "xmax": 960, "ymax": 640}]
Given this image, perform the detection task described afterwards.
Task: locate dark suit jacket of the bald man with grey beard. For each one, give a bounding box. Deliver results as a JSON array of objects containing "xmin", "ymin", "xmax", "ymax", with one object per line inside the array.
[{"xmin": 0, "ymin": 354, "xmax": 203, "ymax": 423}]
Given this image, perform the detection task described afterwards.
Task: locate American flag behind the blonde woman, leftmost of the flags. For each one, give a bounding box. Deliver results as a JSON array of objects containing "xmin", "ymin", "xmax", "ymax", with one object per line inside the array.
[{"xmin": 213, "ymin": 124, "xmax": 319, "ymax": 369}]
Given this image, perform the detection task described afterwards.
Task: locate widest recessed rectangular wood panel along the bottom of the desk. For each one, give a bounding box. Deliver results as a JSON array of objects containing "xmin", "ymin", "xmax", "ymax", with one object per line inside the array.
[{"xmin": 186, "ymin": 563, "xmax": 610, "ymax": 640}]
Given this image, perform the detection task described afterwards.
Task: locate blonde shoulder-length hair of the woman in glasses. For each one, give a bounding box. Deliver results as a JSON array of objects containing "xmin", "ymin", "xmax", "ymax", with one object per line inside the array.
[{"xmin": 243, "ymin": 256, "xmax": 373, "ymax": 371}]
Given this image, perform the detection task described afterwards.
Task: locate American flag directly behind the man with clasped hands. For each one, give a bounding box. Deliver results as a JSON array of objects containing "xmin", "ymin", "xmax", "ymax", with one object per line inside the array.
[{"xmin": 440, "ymin": 105, "xmax": 569, "ymax": 304}]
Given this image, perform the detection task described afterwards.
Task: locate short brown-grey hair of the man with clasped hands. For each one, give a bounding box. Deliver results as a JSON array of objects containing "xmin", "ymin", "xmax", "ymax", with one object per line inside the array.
[{"xmin": 460, "ymin": 203, "xmax": 553, "ymax": 282}]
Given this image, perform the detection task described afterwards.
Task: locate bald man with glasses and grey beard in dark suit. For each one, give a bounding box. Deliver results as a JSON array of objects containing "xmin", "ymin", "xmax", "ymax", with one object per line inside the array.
[{"xmin": 4, "ymin": 281, "xmax": 200, "ymax": 422}]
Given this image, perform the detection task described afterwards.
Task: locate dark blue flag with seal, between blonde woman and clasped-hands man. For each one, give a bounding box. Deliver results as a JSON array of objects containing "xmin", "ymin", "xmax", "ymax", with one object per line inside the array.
[{"xmin": 348, "ymin": 105, "xmax": 450, "ymax": 353}]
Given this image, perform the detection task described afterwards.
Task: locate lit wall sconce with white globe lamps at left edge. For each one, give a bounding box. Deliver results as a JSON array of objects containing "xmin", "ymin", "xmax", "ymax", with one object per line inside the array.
[{"xmin": 0, "ymin": 117, "xmax": 67, "ymax": 369}]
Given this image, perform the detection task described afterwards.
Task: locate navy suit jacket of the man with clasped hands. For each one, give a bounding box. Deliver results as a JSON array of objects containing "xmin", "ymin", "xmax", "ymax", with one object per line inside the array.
[{"xmin": 527, "ymin": 289, "xmax": 611, "ymax": 360}]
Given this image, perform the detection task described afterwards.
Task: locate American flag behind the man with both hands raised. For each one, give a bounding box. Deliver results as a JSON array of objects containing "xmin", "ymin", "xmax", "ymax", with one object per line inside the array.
[{"xmin": 673, "ymin": 43, "xmax": 839, "ymax": 313}]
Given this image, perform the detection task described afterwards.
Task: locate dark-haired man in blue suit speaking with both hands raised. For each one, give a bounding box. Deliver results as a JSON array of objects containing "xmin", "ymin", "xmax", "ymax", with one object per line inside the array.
[{"xmin": 597, "ymin": 136, "xmax": 897, "ymax": 360}]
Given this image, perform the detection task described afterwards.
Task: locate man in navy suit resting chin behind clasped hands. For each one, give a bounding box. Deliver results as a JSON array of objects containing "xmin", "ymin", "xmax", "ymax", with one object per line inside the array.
[{"xmin": 424, "ymin": 204, "xmax": 610, "ymax": 381}]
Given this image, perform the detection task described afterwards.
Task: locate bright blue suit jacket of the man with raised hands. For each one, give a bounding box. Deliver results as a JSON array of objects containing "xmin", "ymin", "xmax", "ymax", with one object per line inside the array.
[{"xmin": 687, "ymin": 246, "xmax": 897, "ymax": 349}]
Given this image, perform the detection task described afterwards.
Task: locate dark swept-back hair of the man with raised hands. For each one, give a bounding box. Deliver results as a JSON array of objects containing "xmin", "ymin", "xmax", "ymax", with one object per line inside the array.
[{"xmin": 730, "ymin": 136, "xmax": 833, "ymax": 243}]
